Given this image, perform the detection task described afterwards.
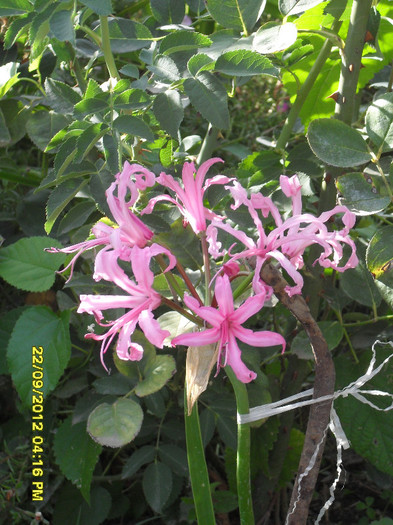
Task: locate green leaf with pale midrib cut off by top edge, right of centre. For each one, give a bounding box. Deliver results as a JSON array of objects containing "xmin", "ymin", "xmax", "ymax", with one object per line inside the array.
[{"xmin": 207, "ymin": 0, "xmax": 266, "ymax": 32}]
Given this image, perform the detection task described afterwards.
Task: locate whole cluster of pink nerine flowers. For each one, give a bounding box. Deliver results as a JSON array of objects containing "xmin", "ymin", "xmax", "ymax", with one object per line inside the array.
[{"xmin": 49, "ymin": 158, "xmax": 357, "ymax": 383}]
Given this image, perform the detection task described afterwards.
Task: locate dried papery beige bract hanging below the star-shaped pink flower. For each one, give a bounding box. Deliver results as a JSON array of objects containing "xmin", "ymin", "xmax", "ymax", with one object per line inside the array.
[{"xmin": 186, "ymin": 344, "xmax": 218, "ymax": 416}]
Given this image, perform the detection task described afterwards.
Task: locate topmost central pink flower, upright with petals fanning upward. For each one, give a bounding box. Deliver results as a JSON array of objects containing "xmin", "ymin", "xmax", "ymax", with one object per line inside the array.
[{"xmin": 142, "ymin": 158, "xmax": 232, "ymax": 234}]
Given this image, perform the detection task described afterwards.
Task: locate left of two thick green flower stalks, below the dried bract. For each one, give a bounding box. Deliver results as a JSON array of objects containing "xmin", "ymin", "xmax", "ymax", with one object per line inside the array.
[{"xmin": 184, "ymin": 385, "xmax": 216, "ymax": 525}]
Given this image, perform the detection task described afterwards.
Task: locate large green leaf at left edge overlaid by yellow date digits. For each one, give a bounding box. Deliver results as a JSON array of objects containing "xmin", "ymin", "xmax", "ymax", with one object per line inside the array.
[{"xmin": 7, "ymin": 306, "xmax": 71, "ymax": 406}]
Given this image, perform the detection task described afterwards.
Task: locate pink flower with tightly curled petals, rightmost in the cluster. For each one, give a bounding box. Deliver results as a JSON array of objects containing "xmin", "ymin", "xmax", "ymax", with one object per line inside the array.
[{"xmin": 207, "ymin": 175, "xmax": 358, "ymax": 295}]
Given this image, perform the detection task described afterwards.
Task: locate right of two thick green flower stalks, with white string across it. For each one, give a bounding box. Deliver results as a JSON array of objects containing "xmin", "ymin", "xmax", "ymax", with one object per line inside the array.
[{"xmin": 225, "ymin": 365, "xmax": 255, "ymax": 525}]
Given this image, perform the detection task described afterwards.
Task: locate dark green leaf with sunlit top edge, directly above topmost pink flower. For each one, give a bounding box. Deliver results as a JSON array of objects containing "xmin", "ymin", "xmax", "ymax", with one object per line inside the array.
[{"xmin": 153, "ymin": 90, "xmax": 184, "ymax": 138}]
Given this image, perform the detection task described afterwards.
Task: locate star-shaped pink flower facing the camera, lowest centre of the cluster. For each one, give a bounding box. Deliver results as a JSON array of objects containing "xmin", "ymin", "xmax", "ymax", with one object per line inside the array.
[{"xmin": 172, "ymin": 275, "xmax": 285, "ymax": 383}]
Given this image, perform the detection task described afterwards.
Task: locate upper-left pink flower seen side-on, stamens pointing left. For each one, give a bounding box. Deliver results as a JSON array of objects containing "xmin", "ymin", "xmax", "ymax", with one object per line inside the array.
[{"xmin": 47, "ymin": 162, "xmax": 156, "ymax": 282}]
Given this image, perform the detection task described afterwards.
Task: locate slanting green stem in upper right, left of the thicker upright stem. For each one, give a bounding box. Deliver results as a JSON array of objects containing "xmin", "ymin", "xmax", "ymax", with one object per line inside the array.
[{"xmin": 276, "ymin": 16, "xmax": 341, "ymax": 150}]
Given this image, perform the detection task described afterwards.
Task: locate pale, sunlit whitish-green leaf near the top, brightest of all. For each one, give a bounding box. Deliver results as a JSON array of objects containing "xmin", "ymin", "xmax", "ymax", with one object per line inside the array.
[{"xmin": 252, "ymin": 22, "xmax": 297, "ymax": 54}]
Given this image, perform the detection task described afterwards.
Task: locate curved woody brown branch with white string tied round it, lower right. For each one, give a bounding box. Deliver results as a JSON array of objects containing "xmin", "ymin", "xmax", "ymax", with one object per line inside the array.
[{"xmin": 261, "ymin": 263, "xmax": 335, "ymax": 525}]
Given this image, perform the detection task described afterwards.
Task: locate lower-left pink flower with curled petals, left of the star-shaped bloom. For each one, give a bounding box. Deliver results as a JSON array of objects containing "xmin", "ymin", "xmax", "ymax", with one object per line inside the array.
[{"xmin": 78, "ymin": 244, "xmax": 176, "ymax": 368}]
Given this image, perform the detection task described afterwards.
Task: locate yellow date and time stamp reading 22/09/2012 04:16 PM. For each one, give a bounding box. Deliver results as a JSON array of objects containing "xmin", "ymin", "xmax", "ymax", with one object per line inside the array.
[{"xmin": 31, "ymin": 346, "xmax": 44, "ymax": 501}]
